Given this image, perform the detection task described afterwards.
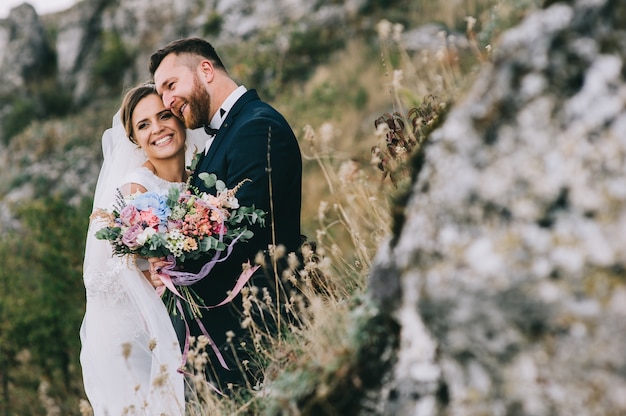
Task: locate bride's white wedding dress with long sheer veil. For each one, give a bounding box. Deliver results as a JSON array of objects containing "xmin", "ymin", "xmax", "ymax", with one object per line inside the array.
[{"xmin": 80, "ymin": 112, "xmax": 206, "ymax": 416}]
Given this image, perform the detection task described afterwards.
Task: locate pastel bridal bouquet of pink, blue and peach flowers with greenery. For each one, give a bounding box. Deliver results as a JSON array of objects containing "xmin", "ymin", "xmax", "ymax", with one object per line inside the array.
[{"xmin": 94, "ymin": 173, "xmax": 265, "ymax": 318}]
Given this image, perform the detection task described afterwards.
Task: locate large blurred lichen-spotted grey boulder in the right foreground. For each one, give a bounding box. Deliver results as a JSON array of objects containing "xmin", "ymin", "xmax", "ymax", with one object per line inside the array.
[{"xmin": 370, "ymin": 0, "xmax": 626, "ymax": 415}]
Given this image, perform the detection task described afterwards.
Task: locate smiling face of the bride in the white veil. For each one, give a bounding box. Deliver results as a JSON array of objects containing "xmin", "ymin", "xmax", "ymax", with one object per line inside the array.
[{"xmin": 131, "ymin": 94, "xmax": 185, "ymax": 160}]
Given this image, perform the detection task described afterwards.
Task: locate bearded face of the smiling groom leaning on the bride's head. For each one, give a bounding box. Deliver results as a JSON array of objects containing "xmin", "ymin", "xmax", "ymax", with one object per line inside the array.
[{"xmin": 154, "ymin": 54, "xmax": 211, "ymax": 129}]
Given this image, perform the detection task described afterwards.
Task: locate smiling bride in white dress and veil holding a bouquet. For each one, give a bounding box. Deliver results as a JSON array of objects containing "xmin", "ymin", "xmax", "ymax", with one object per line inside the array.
[{"xmin": 80, "ymin": 85, "xmax": 207, "ymax": 416}]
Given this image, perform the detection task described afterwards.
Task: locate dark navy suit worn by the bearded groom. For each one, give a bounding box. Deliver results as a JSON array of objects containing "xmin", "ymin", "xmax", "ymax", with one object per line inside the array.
[{"xmin": 178, "ymin": 90, "xmax": 302, "ymax": 384}]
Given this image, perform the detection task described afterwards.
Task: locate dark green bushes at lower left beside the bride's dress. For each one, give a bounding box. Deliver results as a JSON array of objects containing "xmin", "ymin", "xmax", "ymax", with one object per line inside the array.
[{"xmin": 0, "ymin": 197, "xmax": 91, "ymax": 415}]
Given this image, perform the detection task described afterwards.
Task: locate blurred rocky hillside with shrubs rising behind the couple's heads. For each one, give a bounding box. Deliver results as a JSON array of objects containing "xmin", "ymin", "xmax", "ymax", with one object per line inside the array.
[{"xmin": 0, "ymin": 0, "xmax": 395, "ymax": 221}]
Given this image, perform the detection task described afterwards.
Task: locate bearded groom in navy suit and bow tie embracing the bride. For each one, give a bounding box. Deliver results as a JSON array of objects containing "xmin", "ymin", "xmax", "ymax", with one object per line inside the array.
[{"xmin": 149, "ymin": 38, "xmax": 302, "ymax": 388}]
